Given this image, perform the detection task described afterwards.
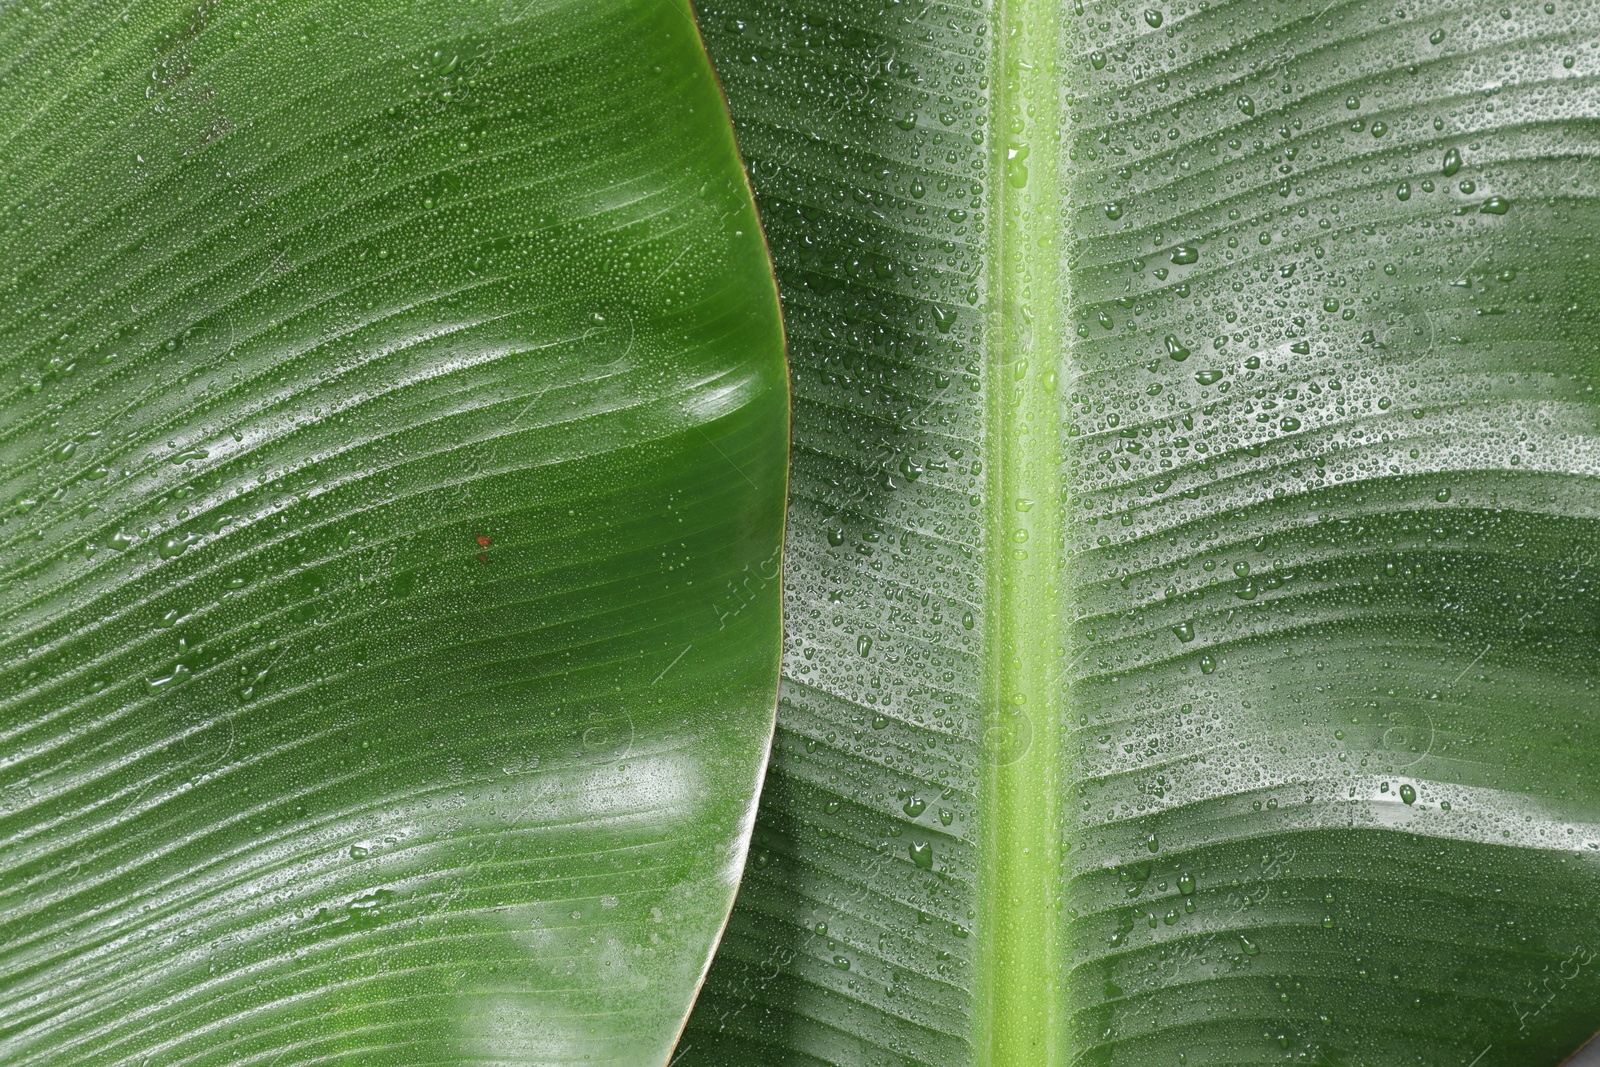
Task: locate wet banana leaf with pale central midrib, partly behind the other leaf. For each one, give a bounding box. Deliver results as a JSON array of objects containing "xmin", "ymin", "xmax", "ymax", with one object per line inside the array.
[{"xmin": 675, "ymin": 0, "xmax": 1600, "ymax": 1067}]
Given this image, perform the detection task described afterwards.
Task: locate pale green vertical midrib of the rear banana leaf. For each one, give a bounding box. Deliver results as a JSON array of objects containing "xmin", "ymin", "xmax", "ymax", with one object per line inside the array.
[{"xmin": 976, "ymin": 0, "xmax": 1066, "ymax": 1067}]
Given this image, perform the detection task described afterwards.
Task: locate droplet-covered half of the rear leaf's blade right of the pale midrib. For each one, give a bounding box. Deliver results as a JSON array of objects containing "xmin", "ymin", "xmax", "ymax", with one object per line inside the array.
[{"xmin": 1061, "ymin": 3, "xmax": 1600, "ymax": 1062}]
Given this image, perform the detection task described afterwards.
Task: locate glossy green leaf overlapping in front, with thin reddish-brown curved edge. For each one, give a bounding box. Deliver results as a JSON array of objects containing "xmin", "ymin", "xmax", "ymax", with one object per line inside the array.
[{"xmin": 0, "ymin": 0, "xmax": 787, "ymax": 1067}]
